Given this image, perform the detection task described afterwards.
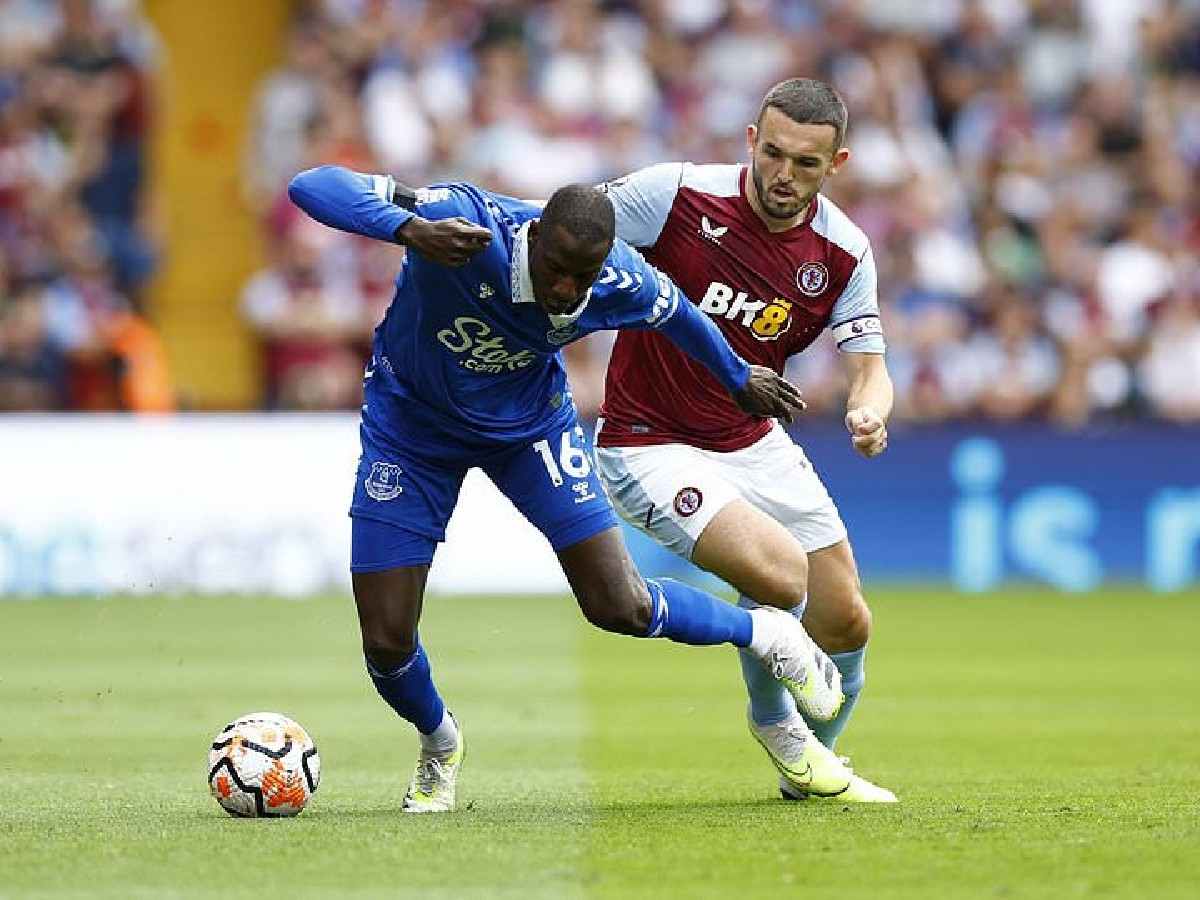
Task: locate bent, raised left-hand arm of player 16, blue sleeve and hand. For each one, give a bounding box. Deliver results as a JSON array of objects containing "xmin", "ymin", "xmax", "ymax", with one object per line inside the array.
[{"xmin": 288, "ymin": 166, "xmax": 492, "ymax": 266}]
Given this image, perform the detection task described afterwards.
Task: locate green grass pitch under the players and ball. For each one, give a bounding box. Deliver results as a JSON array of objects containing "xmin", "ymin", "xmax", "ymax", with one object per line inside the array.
[{"xmin": 0, "ymin": 589, "xmax": 1200, "ymax": 900}]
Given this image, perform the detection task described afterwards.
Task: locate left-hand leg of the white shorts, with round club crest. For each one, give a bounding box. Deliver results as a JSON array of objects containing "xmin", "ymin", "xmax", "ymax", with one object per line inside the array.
[{"xmin": 596, "ymin": 444, "xmax": 739, "ymax": 562}]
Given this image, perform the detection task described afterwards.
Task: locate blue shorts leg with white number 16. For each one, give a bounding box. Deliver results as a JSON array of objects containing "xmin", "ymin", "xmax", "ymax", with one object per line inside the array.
[{"xmin": 482, "ymin": 419, "xmax": 617, "ymax": 552}]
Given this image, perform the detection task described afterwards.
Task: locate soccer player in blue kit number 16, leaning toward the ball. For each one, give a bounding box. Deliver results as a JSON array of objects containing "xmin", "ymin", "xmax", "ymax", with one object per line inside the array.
[{"xmin": 289, "ymin": 166, "xmax": 842, "ymax": 812}]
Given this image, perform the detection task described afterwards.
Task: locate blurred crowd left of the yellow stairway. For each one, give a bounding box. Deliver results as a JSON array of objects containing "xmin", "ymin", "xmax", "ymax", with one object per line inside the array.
[{"xmin": 0, "ymin": 0, "xmax": 173, "ymax": 410}]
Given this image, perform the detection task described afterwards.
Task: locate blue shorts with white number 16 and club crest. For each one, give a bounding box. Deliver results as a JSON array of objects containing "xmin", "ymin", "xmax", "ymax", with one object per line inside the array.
[{"xmin": 350, "ymin": 393, "xmax": 617, "ymax": 572}]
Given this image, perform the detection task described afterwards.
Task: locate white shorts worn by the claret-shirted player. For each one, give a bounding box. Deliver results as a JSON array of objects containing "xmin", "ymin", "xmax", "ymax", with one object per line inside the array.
[{"xmin": 595, "ymin": 424, "xmax": 846, "ymax": 559}]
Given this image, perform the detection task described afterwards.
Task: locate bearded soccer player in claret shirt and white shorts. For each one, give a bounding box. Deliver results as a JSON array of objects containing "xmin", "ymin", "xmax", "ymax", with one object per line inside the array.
[{"xmin": 596, "ymin": 78, "xmax": 895, "ymax": 802}]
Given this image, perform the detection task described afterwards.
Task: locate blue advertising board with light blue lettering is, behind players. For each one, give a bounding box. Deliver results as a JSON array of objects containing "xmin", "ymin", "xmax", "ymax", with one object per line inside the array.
[{"xmin": 626, "ymin": 424, "xmax": 1200, "ymax": 592}]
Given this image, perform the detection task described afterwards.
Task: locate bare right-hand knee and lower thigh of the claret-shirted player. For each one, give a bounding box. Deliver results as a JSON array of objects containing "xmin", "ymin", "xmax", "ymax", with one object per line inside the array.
[{"xmin": 804, "ymin": 539, "xmax": 871, "ymax": 653}]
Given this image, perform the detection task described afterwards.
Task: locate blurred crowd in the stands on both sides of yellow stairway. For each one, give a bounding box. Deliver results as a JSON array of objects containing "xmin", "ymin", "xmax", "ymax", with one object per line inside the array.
[{"xmin": 0, "ymin": 0, "xmax": 1200, "ymax": 425}]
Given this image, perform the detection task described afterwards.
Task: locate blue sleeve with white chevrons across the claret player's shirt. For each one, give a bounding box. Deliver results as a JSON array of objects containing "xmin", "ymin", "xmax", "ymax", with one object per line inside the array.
[{"xmin": 596, "ymin": 242, "xmax": 750, "ymax": 394}]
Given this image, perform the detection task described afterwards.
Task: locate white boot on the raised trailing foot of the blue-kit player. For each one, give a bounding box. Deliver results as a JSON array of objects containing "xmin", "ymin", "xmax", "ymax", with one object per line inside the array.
[{"xmin": 748, "ymin": 606, "xmax": 846, "ymax": 722}]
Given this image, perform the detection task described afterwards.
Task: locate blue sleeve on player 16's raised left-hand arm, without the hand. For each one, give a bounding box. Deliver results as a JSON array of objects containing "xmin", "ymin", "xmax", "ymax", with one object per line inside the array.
[{"xmin": 288, "ymin": 166, "xmax": 414, "ymax": 244}]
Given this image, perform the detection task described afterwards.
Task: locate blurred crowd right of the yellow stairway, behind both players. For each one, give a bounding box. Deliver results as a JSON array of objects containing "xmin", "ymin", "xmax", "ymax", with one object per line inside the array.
[{"xmin": 225, "ymin": 0, "xmax": 1180, "ymax": 425}]
